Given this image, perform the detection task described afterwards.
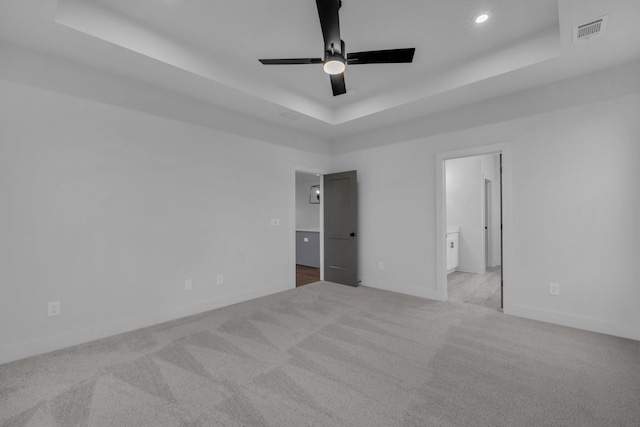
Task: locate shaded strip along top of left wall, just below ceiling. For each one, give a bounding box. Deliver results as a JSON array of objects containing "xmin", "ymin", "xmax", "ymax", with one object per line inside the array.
[{"xmin": 0, "ymin": 42, "xmax": 329, "ymax": 154}]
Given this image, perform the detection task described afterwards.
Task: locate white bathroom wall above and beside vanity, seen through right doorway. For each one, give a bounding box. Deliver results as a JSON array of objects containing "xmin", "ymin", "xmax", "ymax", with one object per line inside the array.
[{"xmin": 446, "ymin": 156, "xmax": 485, "ymax": 273}]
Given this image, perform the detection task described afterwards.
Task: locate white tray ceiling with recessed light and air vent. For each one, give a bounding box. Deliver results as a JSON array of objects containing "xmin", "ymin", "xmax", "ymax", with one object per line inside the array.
[{"xmin": 0, "ymin": 0, "xmax": 640, "ymax": 144}]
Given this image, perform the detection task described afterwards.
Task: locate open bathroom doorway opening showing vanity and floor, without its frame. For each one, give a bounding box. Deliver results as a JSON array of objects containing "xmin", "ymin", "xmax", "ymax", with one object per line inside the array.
[{"xmin": 444, "ymin": 153, "xmax": 503, "ymax": 311}]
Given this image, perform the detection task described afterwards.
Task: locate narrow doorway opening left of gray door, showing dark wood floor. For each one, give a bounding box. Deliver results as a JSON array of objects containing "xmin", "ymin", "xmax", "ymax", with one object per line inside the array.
[{"xmin": 295, "ymin": 171, "xmax": 322, "ymax": 287}]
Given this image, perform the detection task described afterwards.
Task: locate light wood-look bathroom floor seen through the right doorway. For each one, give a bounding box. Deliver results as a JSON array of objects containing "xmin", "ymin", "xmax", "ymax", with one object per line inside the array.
[{"xmin": 447, "ymin": 266, "xmax": 502, "ymax": 311}]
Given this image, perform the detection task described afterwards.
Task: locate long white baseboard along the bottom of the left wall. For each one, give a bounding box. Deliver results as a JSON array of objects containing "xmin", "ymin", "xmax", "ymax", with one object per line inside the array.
[{"xmin": 0, "ymin": 284, "xmax": 292, "ymax": 364}]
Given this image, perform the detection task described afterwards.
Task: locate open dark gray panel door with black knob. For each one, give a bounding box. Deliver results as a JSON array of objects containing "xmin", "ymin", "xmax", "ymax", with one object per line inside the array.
[{"xmin": 324, "ymin": 171, "xmax": 358, "ymax": 286}]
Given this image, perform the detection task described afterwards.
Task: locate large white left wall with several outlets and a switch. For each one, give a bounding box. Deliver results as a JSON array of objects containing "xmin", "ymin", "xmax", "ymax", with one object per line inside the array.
[{"xmin": 0, "ymin": 81, "xmax": 329, "ymax": 363}]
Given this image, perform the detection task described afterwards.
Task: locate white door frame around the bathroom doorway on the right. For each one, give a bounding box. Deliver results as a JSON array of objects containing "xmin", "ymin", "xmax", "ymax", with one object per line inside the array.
[{"xmin": 436, "ymin": 142, "xmax": 513, "ymax": 313}]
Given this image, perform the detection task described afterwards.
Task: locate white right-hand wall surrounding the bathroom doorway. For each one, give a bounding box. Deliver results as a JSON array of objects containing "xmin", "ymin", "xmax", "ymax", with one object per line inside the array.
[{"xmin": 332, "ymin": 87, "xmax": 640, "ymax": 339}]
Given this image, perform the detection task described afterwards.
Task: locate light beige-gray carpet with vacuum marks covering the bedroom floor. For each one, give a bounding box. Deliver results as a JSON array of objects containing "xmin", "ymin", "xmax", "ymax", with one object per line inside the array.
[{"xmin": 0, "ymin": 282, "xmax": 640, "ymax": 427}]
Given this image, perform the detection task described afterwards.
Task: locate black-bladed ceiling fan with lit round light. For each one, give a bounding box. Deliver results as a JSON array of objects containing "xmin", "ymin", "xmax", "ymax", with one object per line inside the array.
[{"xmin": 259, "ymin": 0, "xmax": 416, "ymax": 96}]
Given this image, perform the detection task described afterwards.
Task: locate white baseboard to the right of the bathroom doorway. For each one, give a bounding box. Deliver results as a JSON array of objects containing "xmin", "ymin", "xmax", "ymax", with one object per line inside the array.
[{"xmin": 503, "ymin": 304, "xmax": 640, "ymax": 341}]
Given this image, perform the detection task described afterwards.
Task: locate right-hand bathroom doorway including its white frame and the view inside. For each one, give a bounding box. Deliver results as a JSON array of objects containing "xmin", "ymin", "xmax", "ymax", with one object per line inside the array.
[{"xmin": 436, "ymin": 144, "xmax": 510, "ymax": 311}]
